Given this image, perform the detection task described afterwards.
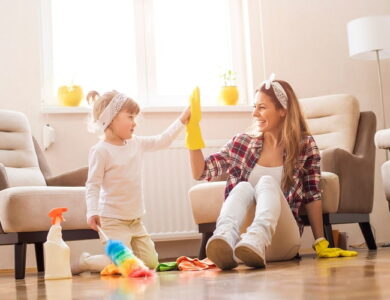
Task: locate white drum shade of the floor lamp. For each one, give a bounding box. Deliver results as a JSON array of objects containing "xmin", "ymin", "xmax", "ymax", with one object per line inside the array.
[{"xmin": 347, "ymin": 16, "xmax": 390, "ymax": 60}]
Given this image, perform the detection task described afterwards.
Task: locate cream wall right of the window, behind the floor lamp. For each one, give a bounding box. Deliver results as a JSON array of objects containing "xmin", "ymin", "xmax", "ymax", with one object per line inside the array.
[{"xmin": 261, "ymin": 0, "xmax": 390, "ymax": 250}]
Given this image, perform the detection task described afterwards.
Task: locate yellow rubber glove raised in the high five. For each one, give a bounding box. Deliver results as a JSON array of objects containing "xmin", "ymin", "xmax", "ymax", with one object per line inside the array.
[{"xmin": 186, "ymin": 87, "xmax": 205, "ymax": 150}]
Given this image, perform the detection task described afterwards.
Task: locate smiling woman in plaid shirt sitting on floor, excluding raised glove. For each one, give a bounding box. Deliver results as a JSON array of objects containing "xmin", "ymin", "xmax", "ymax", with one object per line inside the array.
[{"xmin": 190, "ymin": 74, "xmax": 357, "ymax": 269}]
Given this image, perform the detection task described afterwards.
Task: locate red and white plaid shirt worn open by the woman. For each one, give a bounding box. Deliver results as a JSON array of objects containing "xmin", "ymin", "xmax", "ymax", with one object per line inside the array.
[{"xmin": 200, "ymin": 134, "xmax": 321, "ymax": 234}]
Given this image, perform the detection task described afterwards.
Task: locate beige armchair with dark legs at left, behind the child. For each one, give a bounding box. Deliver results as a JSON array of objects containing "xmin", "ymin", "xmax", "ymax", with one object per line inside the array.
[{"xmin": 0, "ymin": 110, "xmax": 98, "ymax": 279}]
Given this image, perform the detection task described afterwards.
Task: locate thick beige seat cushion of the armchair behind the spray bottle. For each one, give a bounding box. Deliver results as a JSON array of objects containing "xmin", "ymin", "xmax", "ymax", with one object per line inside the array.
[{"xmin": 0, "ymin": 186, "xmax": 89, "ymax": 233}]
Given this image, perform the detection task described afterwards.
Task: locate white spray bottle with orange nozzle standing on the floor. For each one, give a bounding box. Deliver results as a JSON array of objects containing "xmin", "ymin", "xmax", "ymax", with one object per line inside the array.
[{"xmin": 43, "ymin": 207, "xmax": 72, "ymax": 279}]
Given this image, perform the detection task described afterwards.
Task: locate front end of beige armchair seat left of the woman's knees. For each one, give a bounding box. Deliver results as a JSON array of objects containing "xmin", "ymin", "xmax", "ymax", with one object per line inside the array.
[{"xmin": 188, "ymin": 181, "xmax": 226, "ymax": 224}]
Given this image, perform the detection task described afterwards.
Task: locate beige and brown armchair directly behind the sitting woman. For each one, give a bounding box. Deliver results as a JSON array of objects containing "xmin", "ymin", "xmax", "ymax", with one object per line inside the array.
[{"xmin": 189, "ymin": 94, "xmax": 376, "ymax": 258}]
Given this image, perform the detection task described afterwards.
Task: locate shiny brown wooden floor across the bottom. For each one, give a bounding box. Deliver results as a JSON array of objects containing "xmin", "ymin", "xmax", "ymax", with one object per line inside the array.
[{"xmin": 0, "ymin": 248, "xmax": 390, "ymax": 300}]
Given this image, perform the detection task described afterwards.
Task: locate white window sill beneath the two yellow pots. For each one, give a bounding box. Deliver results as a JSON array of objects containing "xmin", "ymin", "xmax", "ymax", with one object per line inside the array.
[{"xmin": 41, "ymin": 104, "xmax": 253, "ymax": 114}]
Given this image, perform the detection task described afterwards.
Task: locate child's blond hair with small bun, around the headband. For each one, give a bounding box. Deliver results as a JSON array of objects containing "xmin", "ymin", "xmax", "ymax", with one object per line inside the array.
[{"xmin": 86, "ymin": 90, "xmax": 140, "ymax": 122}]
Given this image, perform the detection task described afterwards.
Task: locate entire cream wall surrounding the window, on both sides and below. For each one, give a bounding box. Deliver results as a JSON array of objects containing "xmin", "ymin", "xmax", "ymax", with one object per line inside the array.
[{"xmin": 0, "ymin": 0, "xmax": 390, "ymax": 269}]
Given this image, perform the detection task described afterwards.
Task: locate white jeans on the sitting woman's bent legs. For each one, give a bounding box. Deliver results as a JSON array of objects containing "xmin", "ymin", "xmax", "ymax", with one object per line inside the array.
[{"xmin": 217, "ymin": 175, "xmax": 300, "ymax": 261}]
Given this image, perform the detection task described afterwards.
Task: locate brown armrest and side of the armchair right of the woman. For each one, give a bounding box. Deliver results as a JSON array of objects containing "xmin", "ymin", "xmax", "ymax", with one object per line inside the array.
[{"xmin": 321, "ymin": 148, "xmax": 375, "ymax": 213}]
